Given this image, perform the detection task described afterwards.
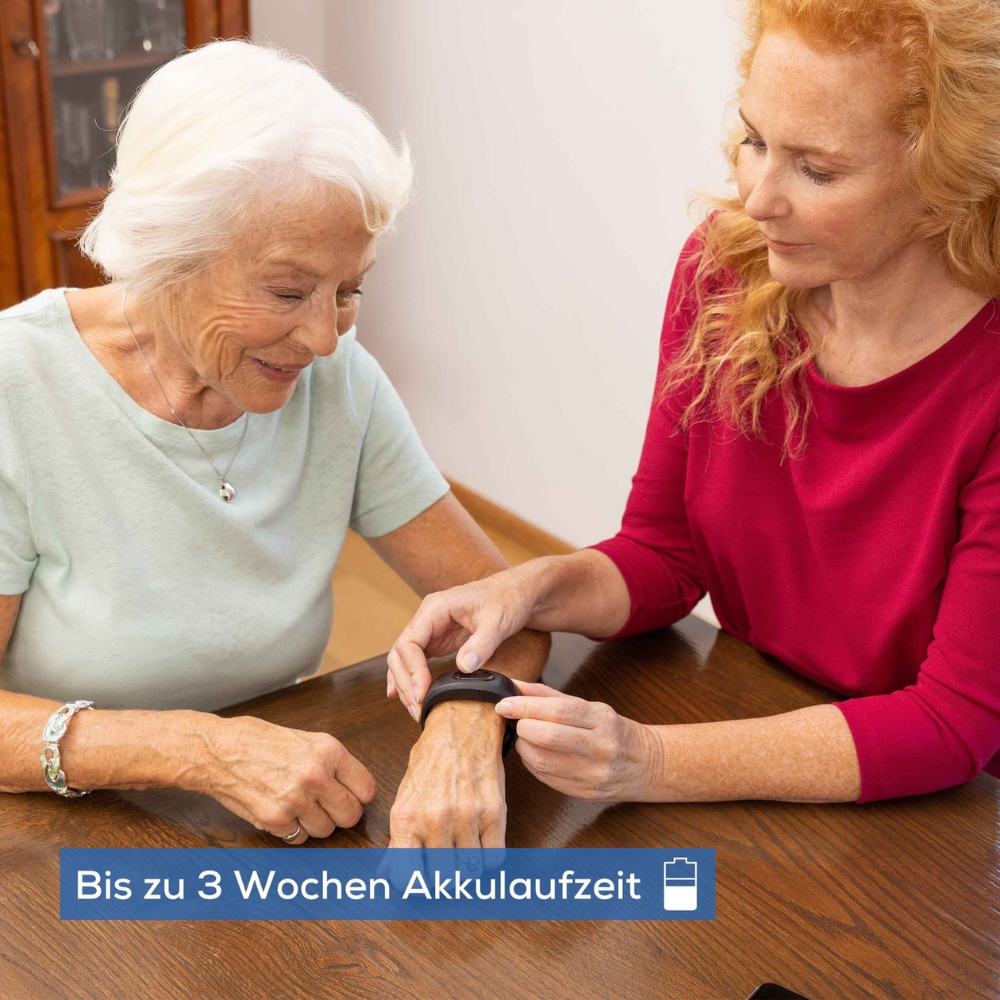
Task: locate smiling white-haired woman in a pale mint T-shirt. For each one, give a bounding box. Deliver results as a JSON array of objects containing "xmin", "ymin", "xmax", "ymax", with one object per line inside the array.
[{"xmin": 0, "ymin": 41, "xmax": 548, "ymax": 847}]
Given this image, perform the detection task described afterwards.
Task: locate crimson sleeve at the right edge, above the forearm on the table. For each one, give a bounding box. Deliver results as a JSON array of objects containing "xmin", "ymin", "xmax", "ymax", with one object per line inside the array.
[{"xmin": 835, "ymin": 402, "xmax": 1000, "ymax": 802}]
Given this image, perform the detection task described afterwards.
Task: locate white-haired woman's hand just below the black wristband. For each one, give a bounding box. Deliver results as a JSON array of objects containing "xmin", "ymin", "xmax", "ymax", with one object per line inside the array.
[{"xmin": 389, "ymin": 702, "xmax": 507, "ymax": 848}]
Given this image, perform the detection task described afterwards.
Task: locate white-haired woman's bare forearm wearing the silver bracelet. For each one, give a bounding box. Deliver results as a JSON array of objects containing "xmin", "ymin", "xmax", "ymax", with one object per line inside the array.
[{"xmin": 0, "ymin": 692, "xmax": 224, "ymax": 792}]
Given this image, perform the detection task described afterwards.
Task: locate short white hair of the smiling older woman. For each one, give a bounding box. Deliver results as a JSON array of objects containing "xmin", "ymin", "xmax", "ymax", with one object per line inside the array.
[{"xmin": 80, "ymin": 41, "xmax": 412, "ymax": 293}]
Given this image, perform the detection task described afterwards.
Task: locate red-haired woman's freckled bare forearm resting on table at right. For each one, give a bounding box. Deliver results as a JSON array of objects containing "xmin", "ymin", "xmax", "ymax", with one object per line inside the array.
[{"xmin": 642, "ymin": 705, "xmax": 861, "ymax": 802}]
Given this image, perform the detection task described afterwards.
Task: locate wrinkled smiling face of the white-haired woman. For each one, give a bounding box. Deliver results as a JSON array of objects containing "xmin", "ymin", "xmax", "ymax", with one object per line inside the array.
[{"xmin": 169, "ymin": 194, "xmax": 375, "ymax": 413}]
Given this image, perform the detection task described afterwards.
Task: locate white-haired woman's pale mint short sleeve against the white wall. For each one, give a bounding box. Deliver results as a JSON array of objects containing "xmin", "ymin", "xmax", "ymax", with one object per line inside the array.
[{"xmin": 346, "ymin": 341, "xmax": 449, "ymax": 538}]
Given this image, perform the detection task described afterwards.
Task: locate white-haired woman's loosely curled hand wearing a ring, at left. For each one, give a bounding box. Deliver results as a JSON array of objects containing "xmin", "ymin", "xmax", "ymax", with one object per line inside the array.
[{"xmin": 198, "ymin": 716, "xmax": 378, "ymax": 844}]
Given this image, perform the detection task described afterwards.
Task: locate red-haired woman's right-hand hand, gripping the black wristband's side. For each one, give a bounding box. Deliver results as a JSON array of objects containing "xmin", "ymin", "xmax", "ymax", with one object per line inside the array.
[{"xmin": 495, "ymin": 681, "xmax": 663, "ymax": 802}]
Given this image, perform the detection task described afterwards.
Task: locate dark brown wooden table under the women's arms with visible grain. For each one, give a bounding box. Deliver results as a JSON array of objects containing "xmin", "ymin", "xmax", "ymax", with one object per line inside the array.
[{"xmin": 0, "ymin": 618, "xmax": 1000, "ymax": 1000}]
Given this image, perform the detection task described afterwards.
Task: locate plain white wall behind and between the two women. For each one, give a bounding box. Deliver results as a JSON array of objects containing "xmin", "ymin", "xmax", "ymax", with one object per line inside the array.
[{"xmin": 252, "ymin": 0, "xmax": 739, "ymax": 615}]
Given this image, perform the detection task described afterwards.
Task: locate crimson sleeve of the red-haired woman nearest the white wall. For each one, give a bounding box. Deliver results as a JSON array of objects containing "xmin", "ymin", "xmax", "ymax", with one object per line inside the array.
[{"xmin": 589, "ymin": 223, "xmax": 706, "ymax": 639}]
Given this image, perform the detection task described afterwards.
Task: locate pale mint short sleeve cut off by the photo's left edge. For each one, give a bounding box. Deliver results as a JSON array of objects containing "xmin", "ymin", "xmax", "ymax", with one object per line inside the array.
[{"xmin": 0, "ymin": 384, "xmax": 38, "ymax": 594}]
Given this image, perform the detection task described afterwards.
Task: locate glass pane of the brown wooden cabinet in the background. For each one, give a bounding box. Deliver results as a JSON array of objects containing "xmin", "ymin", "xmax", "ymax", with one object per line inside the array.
[{"xmin": 39, "ymin": 0, "xmax": 187, "ymax": 203}]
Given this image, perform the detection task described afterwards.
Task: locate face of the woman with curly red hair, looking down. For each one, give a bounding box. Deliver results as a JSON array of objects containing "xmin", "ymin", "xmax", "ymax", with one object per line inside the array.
[{"xmin": 737, "ymin": 32, "xmax": 920, "ymax": 288}]
